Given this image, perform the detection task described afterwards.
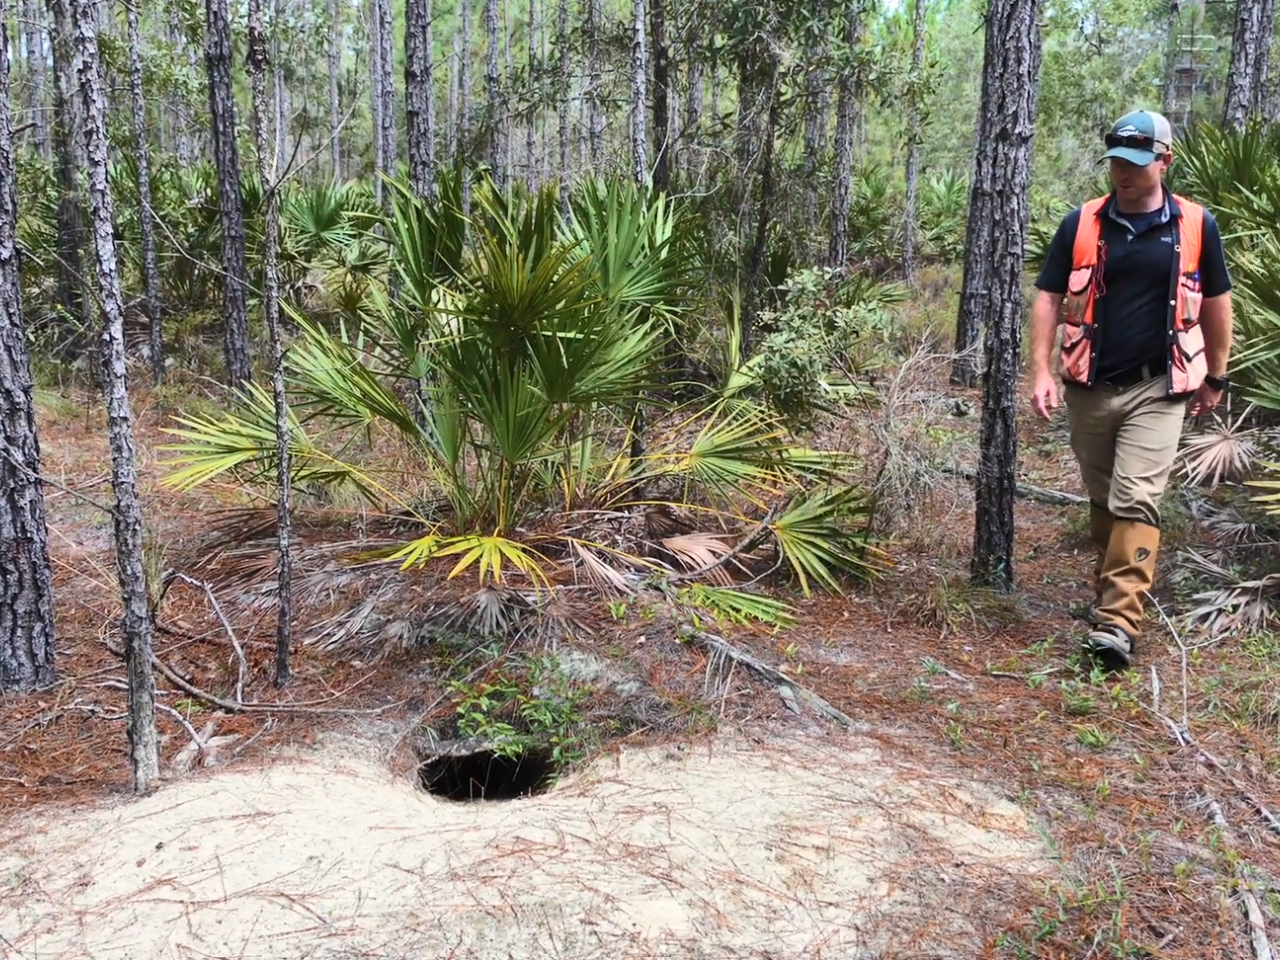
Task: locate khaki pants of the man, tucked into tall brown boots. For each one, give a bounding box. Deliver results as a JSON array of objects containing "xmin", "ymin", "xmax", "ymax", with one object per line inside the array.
[{"xmin": 1062, "ymin": 374, "xmax": 1187, "ymax": 527}]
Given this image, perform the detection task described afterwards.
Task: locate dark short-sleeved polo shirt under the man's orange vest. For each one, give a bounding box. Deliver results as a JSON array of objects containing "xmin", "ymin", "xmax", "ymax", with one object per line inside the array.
[{"xmin": 1036, "ymin": 191, "xmax": 1231, "ymax": 383}]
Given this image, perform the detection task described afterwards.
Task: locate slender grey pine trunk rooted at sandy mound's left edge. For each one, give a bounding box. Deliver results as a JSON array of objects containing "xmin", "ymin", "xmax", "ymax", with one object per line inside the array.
[{"xmin": 72, "ymin": 0, "xmax": 160, "ymax": 794}]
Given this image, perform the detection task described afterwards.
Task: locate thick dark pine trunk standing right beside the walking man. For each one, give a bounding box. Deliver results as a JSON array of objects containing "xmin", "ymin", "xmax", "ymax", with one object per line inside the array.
[{"xmin": 963, "ymin": 0, "xmax": 1041, "ymax": 589}]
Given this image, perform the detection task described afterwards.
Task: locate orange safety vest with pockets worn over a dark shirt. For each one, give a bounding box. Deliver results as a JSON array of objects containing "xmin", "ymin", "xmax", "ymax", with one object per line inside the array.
[{"xmin": 1059, "ymin": 195, "xmax": 1208, "ymax": 396}]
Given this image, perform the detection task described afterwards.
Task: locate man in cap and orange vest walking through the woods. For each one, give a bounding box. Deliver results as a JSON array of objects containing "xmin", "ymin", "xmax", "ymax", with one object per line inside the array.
[{"xmin": 1030, "ymin": 110, "xmax": 1231, "ymax": 669}]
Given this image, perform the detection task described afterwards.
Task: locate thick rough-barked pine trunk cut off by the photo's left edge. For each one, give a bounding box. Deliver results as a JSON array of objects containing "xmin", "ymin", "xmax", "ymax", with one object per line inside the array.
[{"xmin": 0, "ymin": 7, "xmax": 56, "ymax": 694}]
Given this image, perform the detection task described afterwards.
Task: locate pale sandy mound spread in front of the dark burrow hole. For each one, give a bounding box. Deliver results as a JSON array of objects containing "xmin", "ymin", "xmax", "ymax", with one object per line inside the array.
[{"xmin": 0, "ymin": 736, "xmax": 1047, "ymax": 960}]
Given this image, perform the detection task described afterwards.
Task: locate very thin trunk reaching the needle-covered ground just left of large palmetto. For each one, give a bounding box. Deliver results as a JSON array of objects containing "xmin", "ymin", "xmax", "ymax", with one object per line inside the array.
[{"xmin": 248, "ymin": 0, "xmax": 293, "ymax": 687}]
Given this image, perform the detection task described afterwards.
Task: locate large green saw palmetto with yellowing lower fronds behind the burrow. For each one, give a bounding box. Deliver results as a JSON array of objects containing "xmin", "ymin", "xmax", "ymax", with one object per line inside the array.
[{"xmin": 157, "ymin": 172, "xmax": 881, "ymax": 647}]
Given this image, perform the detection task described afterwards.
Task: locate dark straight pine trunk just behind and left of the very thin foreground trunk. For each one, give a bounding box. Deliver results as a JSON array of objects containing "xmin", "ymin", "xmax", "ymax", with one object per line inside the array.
[{"xmin": 203, "ymin": 0, "xmax": 253, "ymax": 387}]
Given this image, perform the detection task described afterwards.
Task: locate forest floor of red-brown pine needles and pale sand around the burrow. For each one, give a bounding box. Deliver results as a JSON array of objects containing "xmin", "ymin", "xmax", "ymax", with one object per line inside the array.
[{"xmin": 0, "ymin": 358, "xmax": 1280, "ymax": 960}]
